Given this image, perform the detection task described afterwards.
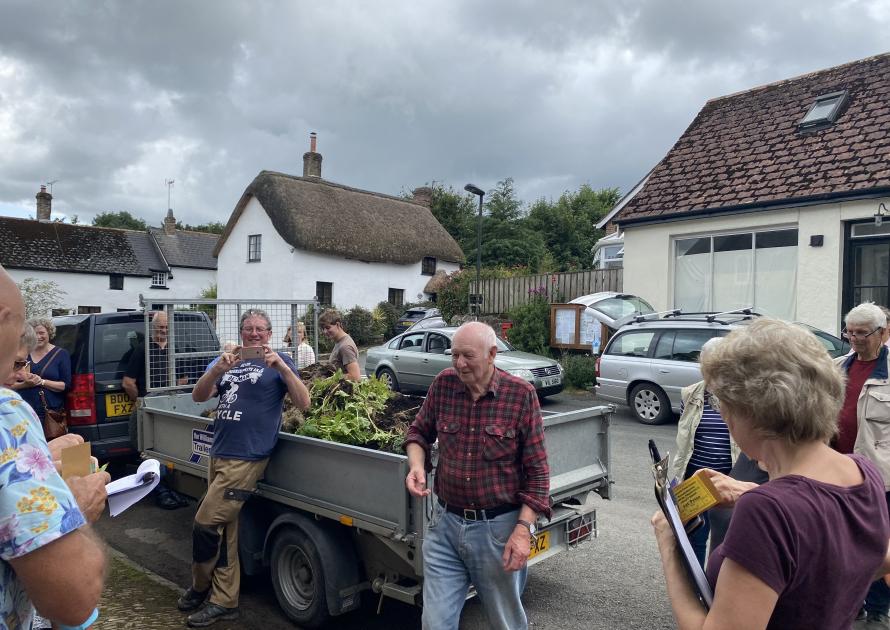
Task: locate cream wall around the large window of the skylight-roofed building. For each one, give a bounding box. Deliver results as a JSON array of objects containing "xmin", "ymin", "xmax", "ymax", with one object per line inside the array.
[{"xmin": 624, "ymin": 199, "xmax": 888, "ymax": 334}]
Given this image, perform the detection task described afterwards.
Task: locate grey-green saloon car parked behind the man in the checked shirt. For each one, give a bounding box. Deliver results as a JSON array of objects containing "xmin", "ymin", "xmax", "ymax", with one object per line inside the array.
[{"xmin": 365, "ymin": 327, "xmax": 563, "ymax": 398}]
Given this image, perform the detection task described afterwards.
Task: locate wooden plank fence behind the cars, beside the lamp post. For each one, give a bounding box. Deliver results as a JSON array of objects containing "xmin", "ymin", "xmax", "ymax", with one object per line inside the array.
[{"xmin": 470, "ymin": 267, "xmax": 624, "ymax": 315}]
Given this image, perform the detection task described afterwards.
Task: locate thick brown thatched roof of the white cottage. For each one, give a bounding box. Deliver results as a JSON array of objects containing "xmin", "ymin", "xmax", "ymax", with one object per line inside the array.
[{"xmin": 213, "ymin": 171, "xmax": 464, "ymax": 264}]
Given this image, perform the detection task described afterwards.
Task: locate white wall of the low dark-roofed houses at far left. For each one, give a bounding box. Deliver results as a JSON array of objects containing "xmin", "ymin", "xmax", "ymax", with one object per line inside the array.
[{"xmin": 6, "ymin": 268, "xmax": 216, "ymax": 315}]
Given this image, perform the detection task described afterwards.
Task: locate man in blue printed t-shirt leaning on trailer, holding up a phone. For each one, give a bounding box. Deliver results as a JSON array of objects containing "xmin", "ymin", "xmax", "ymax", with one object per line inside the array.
[{"xmin": 177, "ymin": 309, "xmax": 309, "ymax": 628}]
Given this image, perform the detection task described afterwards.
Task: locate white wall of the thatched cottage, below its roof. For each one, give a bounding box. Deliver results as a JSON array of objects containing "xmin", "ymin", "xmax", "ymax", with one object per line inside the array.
[{"xmin": 217, "ymin": 198, "xmax": 459, "ymax": 309}]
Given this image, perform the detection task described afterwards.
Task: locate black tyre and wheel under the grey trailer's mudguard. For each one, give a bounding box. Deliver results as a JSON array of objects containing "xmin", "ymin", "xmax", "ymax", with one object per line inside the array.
[{"xmin": 272, "ymin": 528, "xmax": 329, "ymax": 628}]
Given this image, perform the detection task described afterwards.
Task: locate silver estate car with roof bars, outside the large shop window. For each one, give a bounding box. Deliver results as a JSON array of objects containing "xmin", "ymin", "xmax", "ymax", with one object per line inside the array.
[{"xmin": 596, "ymin": 313, "xmax": 850, "ymax": 424}]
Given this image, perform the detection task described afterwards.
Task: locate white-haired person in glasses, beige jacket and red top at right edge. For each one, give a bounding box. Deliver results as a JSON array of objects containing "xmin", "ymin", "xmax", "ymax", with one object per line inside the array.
[{"xmin": 832, "ymin": 302, "xmax": 890, "ymax": 628}]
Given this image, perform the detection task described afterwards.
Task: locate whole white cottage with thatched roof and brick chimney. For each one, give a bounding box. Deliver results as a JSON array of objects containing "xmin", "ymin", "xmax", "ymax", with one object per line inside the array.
[{"xmin": 214, "ymin": 134, "xmax": 463, "ymax": 308}]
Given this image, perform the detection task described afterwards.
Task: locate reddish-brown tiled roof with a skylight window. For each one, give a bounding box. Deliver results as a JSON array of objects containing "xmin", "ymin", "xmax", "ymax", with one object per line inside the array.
[{"xmin": 615, "ymin": 54, "xmax": 890, "ymax": 223}]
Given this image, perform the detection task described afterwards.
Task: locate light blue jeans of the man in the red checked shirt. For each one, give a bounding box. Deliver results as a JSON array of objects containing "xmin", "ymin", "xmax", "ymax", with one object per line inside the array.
[{"xmin": 423, "ymin": 502, "xmax": 528, "ymax": 630}]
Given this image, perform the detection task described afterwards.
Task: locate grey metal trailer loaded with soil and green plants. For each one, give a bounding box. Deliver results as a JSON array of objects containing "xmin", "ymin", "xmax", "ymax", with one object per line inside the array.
[{"xmin": 138, "ymin": 393, "xmax": 614, "ymax": 628}]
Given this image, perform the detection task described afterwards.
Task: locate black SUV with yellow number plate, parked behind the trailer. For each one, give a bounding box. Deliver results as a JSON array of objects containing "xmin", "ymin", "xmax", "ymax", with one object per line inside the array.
[{"xmin": 53, "ymin": 311, "xmax": 219, "ymax": 459}]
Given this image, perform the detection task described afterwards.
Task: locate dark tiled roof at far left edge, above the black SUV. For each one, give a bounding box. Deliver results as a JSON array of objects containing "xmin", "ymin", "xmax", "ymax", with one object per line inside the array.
[{"xmin": 0, "ymin": 217, "xmax": 167, "ymax": 276}]
